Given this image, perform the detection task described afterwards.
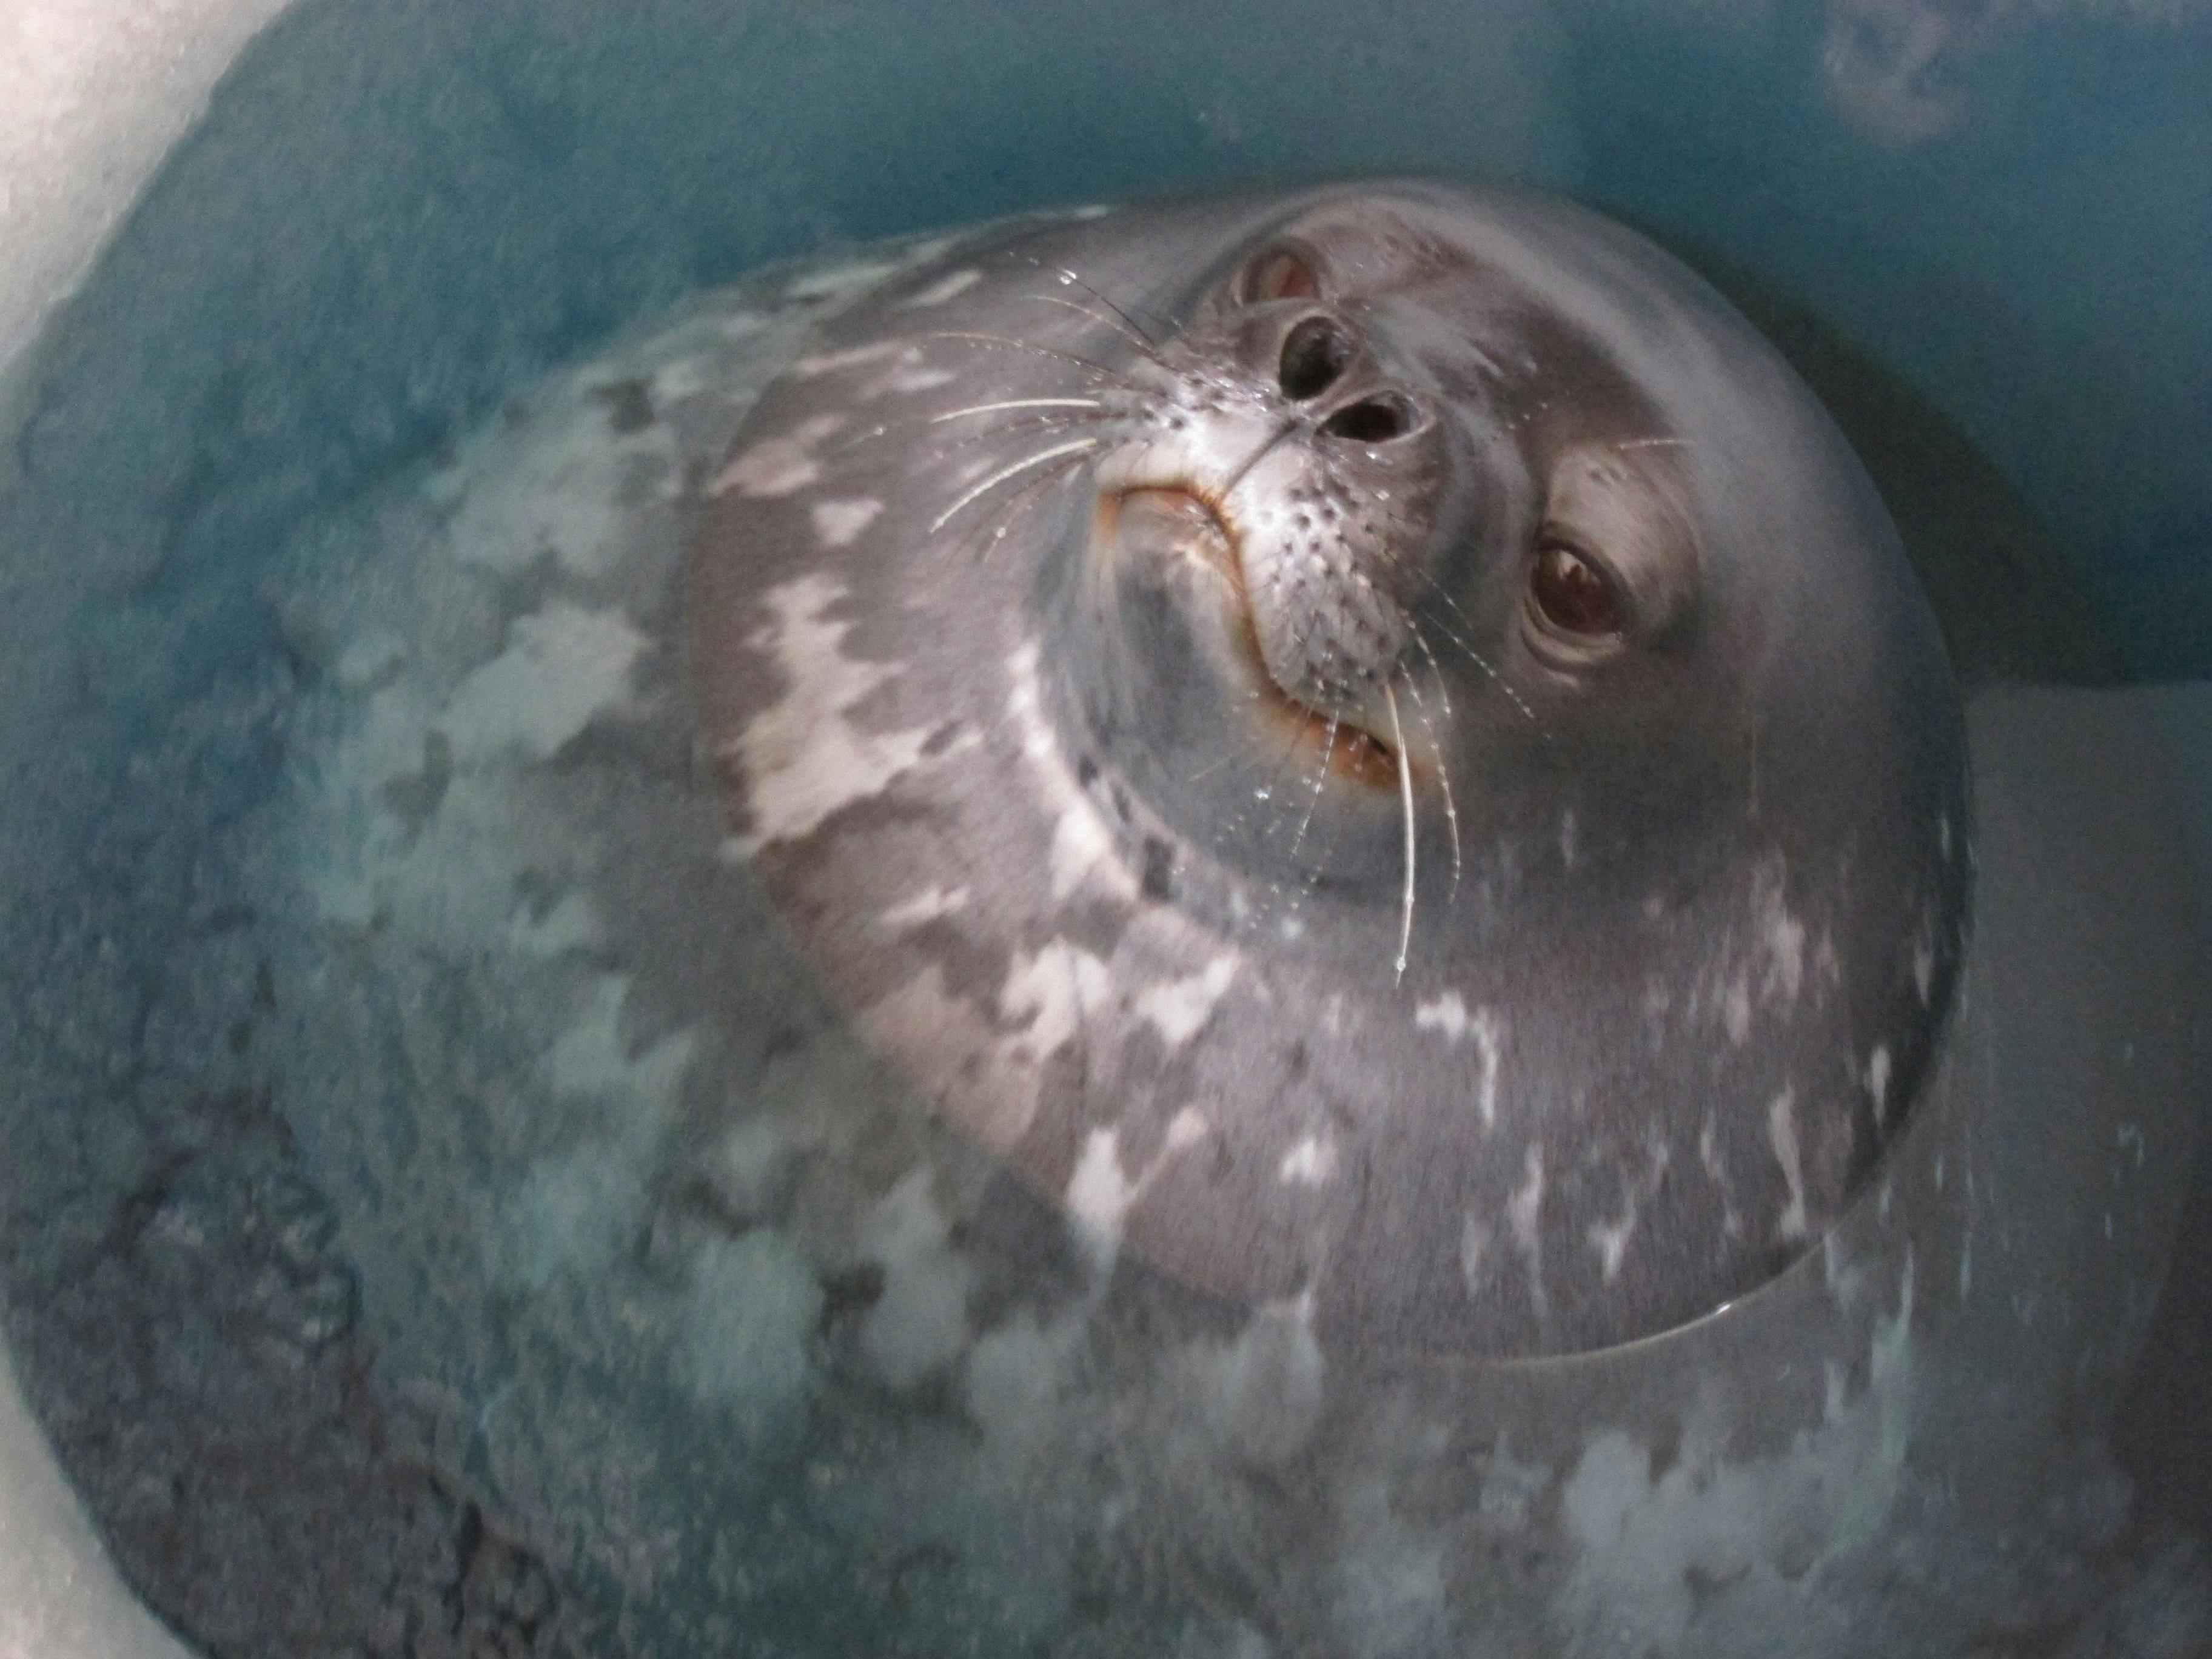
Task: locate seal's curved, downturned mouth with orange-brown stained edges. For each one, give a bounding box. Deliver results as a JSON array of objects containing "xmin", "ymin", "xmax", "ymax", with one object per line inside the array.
[{"xmin": 1099, "ymin": 482, "xmax": 1420, "ymax": 789}]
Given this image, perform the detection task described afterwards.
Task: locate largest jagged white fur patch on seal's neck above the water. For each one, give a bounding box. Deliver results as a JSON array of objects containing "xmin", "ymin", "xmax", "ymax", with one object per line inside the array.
[{"xmin": 723, "ymin": 571, "xmax": 951, "ymax": 851}]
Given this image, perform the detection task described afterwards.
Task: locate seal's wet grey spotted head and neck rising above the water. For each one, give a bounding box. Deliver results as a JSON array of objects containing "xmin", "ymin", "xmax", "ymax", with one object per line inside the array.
[{"xmin": 688, "ymin": 181, "xmax": 1971, "ymax": 1358}]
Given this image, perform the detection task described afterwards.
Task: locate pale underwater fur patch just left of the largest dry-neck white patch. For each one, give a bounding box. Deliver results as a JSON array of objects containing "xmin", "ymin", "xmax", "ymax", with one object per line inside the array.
[{"xmin": 436, "ymin": 602, "xmax": 651, "ymax": 765}]
